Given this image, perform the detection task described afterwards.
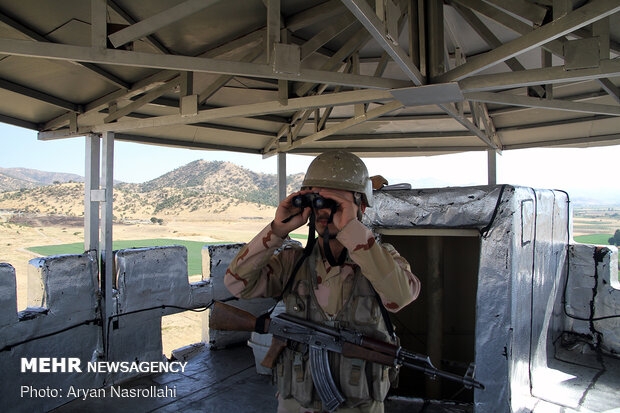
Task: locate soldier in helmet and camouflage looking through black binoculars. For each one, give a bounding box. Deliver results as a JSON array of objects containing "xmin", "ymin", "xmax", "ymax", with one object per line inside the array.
[{"xmin": 224, "ymin": 151, "xmax": 420, "ymax": 413}]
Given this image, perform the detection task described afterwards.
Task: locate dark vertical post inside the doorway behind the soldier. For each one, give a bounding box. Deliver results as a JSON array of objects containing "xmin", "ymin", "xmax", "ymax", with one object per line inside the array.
[{"xmin": 426, "ymin": 237, "xmax": 443, "ymax": 399}]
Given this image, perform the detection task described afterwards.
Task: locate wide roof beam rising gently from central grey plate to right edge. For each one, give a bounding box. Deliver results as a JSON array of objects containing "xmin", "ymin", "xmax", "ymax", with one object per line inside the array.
[{"xmin": 459, "ymin": 59, "xmax": 620, "ymax": 92}]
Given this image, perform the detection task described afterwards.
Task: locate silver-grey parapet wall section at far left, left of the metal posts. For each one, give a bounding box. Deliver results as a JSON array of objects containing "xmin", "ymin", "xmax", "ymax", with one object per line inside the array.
[{"xmin": 0, "ymin": 254, "xmax": 103, "ymax": 412}]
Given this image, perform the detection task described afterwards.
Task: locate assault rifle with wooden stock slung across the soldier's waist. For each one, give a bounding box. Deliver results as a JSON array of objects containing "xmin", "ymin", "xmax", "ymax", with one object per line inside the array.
[{"xmin": 209, "ymin": 301, "xmax": 484, "ymax": 412}]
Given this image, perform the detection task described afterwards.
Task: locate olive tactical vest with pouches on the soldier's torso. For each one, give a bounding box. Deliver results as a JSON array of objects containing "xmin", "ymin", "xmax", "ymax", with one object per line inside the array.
[{"xmin": 276, "ymin": 246, "xmax": 396, "ymax": 409}]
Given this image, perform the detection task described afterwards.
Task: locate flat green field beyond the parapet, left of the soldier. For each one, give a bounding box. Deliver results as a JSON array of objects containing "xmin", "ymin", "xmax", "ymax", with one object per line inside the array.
[{"xmin": 27, "ymin": 239, "xmax": 235, "ymax": 275}]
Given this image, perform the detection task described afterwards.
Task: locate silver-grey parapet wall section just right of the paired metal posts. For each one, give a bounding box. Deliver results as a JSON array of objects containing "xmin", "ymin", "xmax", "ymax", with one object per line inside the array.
[{"xmin": 106, "ymin": 246, "xmax": 212, "ymax": 384}]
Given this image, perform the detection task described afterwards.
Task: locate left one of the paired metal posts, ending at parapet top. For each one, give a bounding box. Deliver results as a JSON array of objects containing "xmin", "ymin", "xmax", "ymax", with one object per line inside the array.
[{"xmin": 84, "ymin": 135, "xmax": 100, "ymax": 251}]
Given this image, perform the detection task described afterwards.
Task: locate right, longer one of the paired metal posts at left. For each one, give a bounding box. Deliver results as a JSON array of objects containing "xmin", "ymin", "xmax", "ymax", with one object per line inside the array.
[{"xmin": 101, "ymin": 132, "xmax": 114, "ymax": 358}]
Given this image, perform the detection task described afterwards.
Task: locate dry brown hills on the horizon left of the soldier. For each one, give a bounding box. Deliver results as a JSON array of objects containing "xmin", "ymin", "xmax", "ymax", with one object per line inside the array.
[{"xmin": 0, "ymin": 160, "xmax": 303, "ymax": 221}]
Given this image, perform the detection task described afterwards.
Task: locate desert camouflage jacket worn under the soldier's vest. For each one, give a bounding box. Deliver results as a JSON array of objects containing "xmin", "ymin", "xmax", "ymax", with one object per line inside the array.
[{"xmin": 224, "ymin": 220, "xmax": 420, "ymax": 317}]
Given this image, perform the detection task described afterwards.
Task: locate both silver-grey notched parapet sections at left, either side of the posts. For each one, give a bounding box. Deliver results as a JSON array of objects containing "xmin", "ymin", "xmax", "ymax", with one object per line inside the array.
[{"xmin": 0, "ymin": 246, "xmax": 212, "ymax": 412}]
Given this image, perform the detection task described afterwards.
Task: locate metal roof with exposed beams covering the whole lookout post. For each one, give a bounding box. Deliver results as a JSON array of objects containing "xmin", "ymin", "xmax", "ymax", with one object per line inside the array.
[{"xmin": 0, "ymin": 0, "xmax": 620, "ymax": 156}]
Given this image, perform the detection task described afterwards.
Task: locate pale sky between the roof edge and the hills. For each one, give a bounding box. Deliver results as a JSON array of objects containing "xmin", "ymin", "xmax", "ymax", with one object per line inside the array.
[{"xmin": 0, "ymin": 123, "xmax": 620, "ymax": 204}]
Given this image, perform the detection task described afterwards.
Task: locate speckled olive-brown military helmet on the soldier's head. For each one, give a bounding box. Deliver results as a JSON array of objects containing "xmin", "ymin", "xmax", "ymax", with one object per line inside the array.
[{"xmin": 301, "ymin": 150, "xmax": 372, "ymax": 206}]
